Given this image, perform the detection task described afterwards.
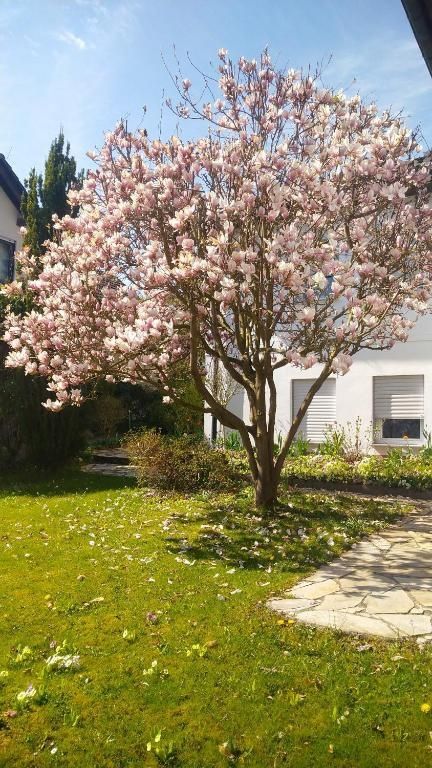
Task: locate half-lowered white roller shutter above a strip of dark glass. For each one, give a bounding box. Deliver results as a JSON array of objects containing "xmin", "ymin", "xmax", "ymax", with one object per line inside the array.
[{"xmin": 374, "ymin": 376, "xmax": 424, "ymax": 419}]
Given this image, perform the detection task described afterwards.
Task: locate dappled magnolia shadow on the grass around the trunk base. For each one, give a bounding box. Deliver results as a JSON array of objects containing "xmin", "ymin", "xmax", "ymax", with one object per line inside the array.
[{"xmin": 165, "ymin": 491, "xmax": 400, "ymax": 573}]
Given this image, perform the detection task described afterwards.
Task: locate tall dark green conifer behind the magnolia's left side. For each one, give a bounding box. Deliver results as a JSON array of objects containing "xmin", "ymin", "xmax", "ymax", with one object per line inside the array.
[{"xmin": 0, "ymin": 131, "xmax": 86, "ymax": 467}]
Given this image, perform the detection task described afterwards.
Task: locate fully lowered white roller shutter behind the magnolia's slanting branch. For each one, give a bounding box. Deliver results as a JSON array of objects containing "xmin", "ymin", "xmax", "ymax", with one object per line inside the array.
[{"xmin": 292, "ymin": 379, "xmax": 336, "ymax": 443}]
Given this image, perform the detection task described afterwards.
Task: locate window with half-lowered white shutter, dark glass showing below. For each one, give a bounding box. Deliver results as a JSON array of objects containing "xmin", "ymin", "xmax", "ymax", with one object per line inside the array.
[{"xmin": 373, "ymin": 376, "xmax": 424, "ymax": 443}]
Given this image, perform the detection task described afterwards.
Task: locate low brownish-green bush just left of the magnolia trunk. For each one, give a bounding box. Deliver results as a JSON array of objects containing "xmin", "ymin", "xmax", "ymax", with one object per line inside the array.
[{"xmin": 125, "ymin": 430, "xmax": 233, "ymax": 491}]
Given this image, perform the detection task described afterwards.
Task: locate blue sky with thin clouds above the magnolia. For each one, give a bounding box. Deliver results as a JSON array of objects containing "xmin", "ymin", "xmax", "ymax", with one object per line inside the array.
[{"xmin": 0, "ymin": 0, "xmax": 432, "ymax": 179}]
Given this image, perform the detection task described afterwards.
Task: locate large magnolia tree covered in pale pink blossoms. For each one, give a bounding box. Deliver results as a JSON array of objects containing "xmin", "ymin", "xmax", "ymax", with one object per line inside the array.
[{"xmin": 5, "ymin": 50, "xmax": 432, "ymax": 506}]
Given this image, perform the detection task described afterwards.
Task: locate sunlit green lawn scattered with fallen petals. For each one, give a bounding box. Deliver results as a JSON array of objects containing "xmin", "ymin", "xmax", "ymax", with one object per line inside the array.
[{"xmin": 0, "ymin": 473, "xmax": 432, "ymax": 768}]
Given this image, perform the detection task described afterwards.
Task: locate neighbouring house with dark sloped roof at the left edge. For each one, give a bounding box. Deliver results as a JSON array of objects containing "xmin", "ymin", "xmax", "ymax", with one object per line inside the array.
[{"xmin": 0, "ymin": 154, "xmax": 24, "ymax": 283}]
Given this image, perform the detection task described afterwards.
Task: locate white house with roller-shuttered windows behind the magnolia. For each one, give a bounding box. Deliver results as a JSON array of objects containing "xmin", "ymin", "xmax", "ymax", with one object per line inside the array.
[{"xmin": 204, "ymin": 316, "xmax": 432, "ymax": 453}]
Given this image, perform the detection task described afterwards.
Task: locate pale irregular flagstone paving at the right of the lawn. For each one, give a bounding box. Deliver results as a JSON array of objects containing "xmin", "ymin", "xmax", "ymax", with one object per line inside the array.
[{"xmin": 268, "ymin": 503, "xmax": 432, "ymax": 644}]
